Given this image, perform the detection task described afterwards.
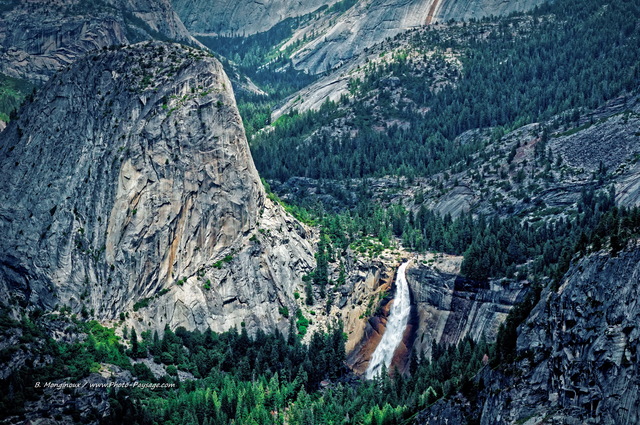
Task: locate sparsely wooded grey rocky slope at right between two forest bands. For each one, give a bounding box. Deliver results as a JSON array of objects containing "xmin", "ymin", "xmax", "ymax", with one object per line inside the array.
[{"xmin": 396, "ymin": 97, "xmax": 640, "ymax": 220}]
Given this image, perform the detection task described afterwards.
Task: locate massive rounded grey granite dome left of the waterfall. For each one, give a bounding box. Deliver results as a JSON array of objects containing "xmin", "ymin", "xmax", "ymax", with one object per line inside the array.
[{"xmin": 0, "ymin": 42, "xmax": 314, "ymax": 331}]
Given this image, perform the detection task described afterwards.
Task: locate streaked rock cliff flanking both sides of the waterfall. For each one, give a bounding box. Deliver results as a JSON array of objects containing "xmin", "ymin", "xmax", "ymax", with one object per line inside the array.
[{"xmin": 340, "ymin": 253, "xmax": 527, "ymax": 374}]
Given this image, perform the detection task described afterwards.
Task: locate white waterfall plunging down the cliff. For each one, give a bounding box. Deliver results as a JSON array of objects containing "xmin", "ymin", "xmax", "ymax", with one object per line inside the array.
[{"xmin": 365, "ymin": 263, "xmax": 411, "ymax": 379}]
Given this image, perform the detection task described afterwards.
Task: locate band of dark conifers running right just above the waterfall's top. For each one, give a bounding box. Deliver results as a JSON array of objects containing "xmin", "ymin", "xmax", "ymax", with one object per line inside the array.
[{"xmin": 304, "ymin": 187, "xmax": 640, "ymax": 285}]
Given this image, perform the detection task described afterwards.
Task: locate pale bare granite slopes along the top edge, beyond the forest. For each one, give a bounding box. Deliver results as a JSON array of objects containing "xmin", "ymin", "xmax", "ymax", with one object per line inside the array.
[{"xmin": 173, "ymin": 0, "xmax": 545, "ymax": 74}]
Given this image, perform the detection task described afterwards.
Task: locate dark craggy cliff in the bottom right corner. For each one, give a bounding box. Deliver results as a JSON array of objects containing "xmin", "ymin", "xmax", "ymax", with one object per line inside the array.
[{"xmin": 481, "ymin": 247, "xmax": 640, "ymax": 425}]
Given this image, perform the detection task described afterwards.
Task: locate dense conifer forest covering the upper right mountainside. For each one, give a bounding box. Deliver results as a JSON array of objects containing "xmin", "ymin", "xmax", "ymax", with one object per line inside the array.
[{"xmin": 246, "ymin": 0, "xmax": 640, "ymax": 180}]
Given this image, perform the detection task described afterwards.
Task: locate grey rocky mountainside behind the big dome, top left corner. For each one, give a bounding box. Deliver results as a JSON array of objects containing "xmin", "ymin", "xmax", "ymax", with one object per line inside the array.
[{"xmin": 0, "ymin": 0, "xmax": 196, "ymax": 83}]
